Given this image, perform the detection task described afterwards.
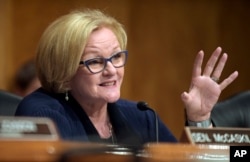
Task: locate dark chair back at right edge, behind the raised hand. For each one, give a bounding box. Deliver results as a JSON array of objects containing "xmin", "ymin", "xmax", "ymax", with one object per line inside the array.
[{"xmin": 211, "ymin": 91, "xmax": 250, "ymax": 128}]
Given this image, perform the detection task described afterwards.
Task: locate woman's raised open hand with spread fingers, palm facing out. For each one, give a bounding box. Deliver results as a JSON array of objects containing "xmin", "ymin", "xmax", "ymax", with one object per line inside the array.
[{"xmin": 181, "ymin": 47, "xmax": 238, "ymax": 121}]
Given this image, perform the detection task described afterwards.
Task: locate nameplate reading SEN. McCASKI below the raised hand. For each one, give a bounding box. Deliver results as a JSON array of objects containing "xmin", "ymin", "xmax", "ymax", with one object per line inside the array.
[{"xmin": 180, "ymin": 127, "xmax": 250, "ymax": 145}]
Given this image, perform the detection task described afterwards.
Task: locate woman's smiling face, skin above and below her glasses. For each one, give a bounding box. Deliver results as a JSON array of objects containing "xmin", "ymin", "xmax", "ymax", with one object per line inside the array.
[{"xmin": 70, "ymin": 27, "xmax": 124, "ymax": 102}]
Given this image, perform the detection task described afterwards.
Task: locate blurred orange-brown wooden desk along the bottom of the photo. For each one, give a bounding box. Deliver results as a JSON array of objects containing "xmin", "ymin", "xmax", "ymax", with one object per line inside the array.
[{"xmin": 0, "ymin": 140, "xmax": 229, "ymax": 162}]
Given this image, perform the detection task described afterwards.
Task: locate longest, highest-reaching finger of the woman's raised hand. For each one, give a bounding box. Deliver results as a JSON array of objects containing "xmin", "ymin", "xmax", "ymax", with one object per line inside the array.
[{"xmin": 203, "ymin": 47, "xmax": 222, "ymax": 76}]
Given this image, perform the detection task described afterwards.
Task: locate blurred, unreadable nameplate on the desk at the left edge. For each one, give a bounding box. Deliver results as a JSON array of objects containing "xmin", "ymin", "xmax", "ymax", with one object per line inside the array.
[{"xmin": 0, "ymin": 116, "xmax": 59, "ymax": 140}]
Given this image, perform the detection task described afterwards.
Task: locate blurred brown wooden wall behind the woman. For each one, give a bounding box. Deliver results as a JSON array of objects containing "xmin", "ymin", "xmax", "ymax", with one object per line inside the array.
[{"xmin": 0, "ymin": 0, "xmax": 250, "ymax": 138}]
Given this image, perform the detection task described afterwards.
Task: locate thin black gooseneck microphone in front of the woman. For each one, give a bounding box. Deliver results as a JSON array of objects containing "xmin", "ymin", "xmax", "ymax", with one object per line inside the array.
[{"xmin": 137, "ymin": 101, "xmax": 159, "ymax": 143}]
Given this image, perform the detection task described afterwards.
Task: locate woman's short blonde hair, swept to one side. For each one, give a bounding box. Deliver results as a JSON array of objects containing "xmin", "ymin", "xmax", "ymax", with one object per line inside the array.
[{"xmin": 36, "ymin": 9, "xmax": 127, "ymax": 93}]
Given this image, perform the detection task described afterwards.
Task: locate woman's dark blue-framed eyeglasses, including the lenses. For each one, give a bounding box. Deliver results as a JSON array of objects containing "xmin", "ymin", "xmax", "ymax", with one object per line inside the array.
[{"xmin": 80, "ymin": 50, "xmax": 128, "ymax": 74}]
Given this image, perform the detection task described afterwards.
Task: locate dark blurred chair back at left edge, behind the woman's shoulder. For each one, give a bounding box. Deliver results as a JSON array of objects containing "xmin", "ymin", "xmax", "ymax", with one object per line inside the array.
[{"xmin": 0, "ymin": 90, "xmax": 22, "ymax": 116}]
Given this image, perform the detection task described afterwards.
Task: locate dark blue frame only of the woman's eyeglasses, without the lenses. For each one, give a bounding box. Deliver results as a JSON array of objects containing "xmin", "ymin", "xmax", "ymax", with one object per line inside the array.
[{"xmin": 79, "ymin": 50, "xmax": 128, "ymax": 74}]
